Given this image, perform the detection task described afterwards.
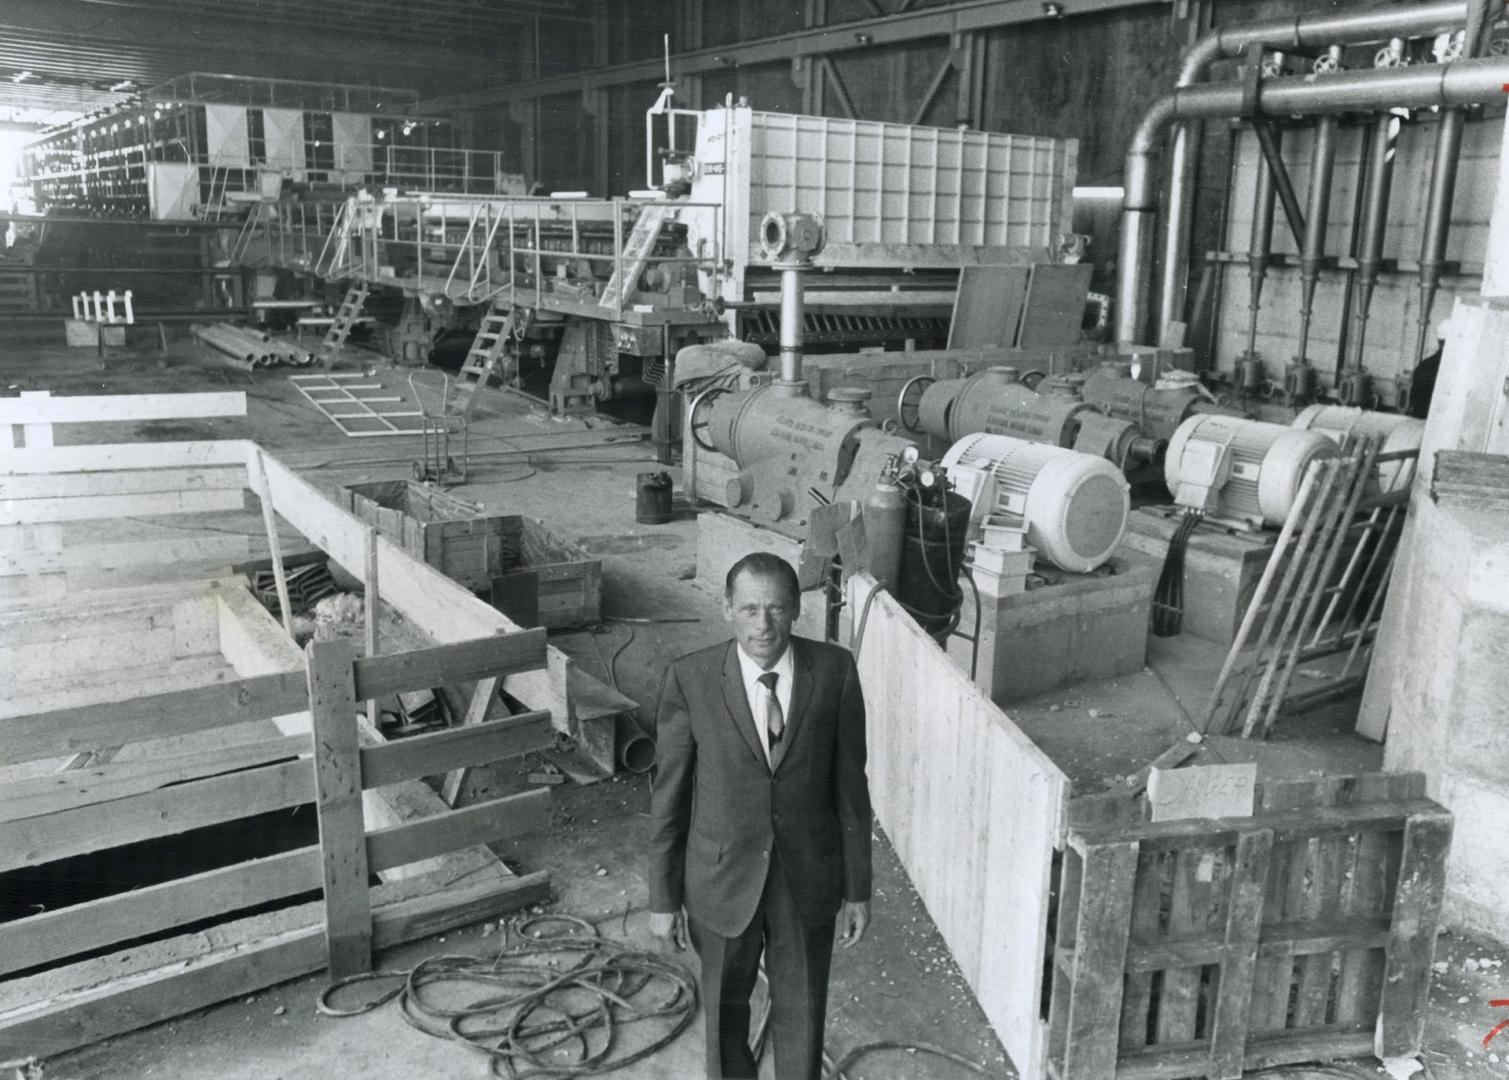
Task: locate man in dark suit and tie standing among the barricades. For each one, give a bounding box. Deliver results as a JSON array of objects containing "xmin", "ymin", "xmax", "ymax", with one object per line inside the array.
[{"xmin": 649, "ymin": 552, "xmax": 871, "ymax": 1080}]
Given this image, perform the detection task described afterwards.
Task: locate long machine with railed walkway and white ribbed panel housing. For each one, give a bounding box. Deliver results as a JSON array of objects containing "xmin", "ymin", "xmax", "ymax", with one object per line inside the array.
[{"xmin": 223, "ymin": 85, "xmax": 1074, "ymax": 443}]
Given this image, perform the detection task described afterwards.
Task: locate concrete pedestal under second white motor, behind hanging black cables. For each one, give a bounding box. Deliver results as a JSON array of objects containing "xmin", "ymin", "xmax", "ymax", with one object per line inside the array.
[{"xmin": 1121, "ymin": 507, "xmax": 1278, "ymax": 646}]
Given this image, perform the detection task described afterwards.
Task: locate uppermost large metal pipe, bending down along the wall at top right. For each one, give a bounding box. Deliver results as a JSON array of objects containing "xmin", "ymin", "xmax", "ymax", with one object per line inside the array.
[{"xmin": 1140, "ymin": 0, "xmax": 1472, "ymax": 341}]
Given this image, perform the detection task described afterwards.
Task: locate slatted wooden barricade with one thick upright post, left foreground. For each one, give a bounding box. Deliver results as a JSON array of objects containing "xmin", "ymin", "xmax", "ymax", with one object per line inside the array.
[{"xmin": 0, "ymin": 629, "xmax": 552, "ymax": 1056}]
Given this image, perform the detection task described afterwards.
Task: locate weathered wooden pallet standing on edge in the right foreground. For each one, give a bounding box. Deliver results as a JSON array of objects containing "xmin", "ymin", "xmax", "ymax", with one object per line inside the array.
[{"xmin": 1047, "ymin": 774, "xmax": 1452, "ymax": 1080}]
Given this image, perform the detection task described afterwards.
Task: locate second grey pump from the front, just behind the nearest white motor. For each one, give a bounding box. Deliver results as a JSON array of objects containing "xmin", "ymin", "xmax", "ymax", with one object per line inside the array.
[{"xmin": 896, "ymin": 367, "xmax": 1163, "ymax": 469}]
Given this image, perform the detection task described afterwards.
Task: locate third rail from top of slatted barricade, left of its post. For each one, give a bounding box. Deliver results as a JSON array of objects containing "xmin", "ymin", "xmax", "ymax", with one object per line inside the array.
[{"xmin": 0, "ymin": 846, "xmax": 320, "ymax": 976}]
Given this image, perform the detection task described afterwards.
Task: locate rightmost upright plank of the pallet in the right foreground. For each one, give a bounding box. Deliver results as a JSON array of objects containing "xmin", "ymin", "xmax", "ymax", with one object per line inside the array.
[{"xmin": 1375, "ymin": 810, "xmax": 1452, "ymax": 1057}]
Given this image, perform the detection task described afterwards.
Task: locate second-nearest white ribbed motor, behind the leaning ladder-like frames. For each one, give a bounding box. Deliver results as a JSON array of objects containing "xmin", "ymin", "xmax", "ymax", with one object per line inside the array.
[{"xmin": 1163, "ymin": 416, "xmax": 1337, "ymax": 528}]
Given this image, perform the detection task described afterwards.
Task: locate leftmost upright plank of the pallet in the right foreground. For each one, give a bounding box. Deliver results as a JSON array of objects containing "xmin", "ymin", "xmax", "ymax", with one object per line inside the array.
[{"xmin": 1062, "ymin": 842, "xmax": 1138, "ymax": 1080}]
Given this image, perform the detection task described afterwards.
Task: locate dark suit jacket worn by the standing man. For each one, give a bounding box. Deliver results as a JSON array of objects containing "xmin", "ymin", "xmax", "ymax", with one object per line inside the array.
[{"xmin": 649, "ymin": 638, "xmax": 871, "ymax": 937}]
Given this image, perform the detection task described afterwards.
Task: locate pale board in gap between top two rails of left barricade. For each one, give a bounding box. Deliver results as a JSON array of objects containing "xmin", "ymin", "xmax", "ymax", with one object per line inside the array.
[{"xmin": 0, "ymin": 735, "xmax": 309, "ymax": 821}]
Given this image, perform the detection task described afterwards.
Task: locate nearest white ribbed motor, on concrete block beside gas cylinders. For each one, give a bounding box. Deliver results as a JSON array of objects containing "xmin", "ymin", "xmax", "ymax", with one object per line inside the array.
[{"xmin": 942, "ymin": 433, "xmax": 1130, "ymax": 573}]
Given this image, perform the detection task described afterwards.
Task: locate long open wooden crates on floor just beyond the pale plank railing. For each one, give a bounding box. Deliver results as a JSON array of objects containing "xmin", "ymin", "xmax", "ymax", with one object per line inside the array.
[{"xmin": 338, "ymin": 480, "xmax": 602, "ymax": 629}]
